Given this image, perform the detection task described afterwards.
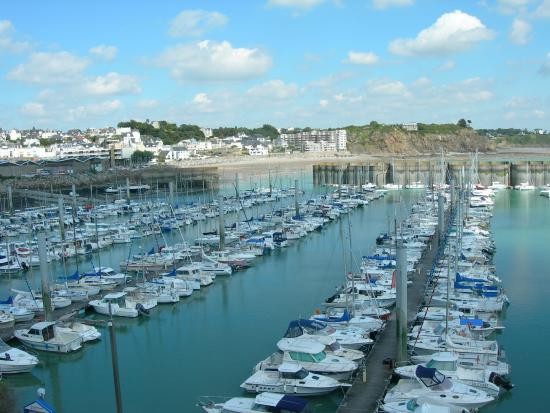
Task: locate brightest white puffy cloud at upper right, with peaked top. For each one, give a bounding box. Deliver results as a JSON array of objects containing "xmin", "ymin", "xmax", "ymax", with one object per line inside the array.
[{"xmin": 389, "ymin": 10, "xmax": 493, "ymax": 56}]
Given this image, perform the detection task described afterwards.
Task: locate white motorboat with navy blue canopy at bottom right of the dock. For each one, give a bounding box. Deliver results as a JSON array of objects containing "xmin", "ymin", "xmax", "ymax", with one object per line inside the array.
[{"xmin": 384, "ymin": 366, "xmax": 494, "ymax": 409}]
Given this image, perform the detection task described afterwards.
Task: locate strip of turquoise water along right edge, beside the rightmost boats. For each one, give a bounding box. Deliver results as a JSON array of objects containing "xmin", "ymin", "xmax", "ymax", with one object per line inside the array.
[{"xmin": 484, "ymin": 191, "xmax": 550, "ymax": 413}]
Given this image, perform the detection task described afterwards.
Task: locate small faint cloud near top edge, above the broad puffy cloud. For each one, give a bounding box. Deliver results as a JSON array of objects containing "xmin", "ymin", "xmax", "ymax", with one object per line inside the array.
[{"xmin": 168, "ymin": 10, "xmax": 228, "ymax": 37}]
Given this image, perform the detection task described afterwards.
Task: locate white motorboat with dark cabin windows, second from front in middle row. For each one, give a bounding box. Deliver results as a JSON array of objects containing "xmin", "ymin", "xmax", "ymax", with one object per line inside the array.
[{"xmin": 241, "ymin": 362, "xmax": 342, "ymax": 396}]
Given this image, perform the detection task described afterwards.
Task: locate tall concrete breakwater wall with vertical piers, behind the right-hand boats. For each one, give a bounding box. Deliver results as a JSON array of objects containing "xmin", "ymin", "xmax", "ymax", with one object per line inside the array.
[{"xmin": 313, "ymin": 157, "xmax": 550, "ymax": 186}]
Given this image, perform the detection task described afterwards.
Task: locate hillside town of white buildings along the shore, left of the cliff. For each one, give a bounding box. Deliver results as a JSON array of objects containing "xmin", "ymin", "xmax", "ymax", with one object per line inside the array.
[{"xmin": 0, "ymin": 122, "xmax": 347, "ymax": 162}]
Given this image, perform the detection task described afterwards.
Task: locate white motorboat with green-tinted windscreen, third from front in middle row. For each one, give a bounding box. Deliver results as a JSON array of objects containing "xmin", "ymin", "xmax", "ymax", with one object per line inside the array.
[{"xmin": 256, "ymin": 338, "xmax": 358, "ymax": 380}]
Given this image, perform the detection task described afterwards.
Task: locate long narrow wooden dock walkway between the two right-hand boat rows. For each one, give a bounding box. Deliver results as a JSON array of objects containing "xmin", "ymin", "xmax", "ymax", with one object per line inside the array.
[{"xmin": 337, "ymin": 235, "xmax": 448, "ymax": 413}]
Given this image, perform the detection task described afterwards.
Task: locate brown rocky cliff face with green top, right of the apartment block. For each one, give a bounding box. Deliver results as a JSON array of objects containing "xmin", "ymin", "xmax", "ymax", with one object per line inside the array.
[{"xmin": 347, "ymin": 126, "xmax": 494, "ymax": 155}]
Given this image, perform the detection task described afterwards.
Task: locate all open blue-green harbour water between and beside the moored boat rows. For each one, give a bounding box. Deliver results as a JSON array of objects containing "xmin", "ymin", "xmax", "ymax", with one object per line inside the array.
[{"xmin": 2, "ymin": 191, "xmax": 550, "ymax": 413}]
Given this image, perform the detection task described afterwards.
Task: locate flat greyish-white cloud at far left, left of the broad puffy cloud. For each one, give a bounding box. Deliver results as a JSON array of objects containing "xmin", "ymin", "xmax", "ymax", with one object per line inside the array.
[{"xmin": 7, "ymin": 52, "xmax": 89, "ymax": 84}]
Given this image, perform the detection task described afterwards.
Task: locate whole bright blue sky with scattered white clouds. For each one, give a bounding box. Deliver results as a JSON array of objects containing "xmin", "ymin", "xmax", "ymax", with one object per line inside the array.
[{"xmin": 0, "ymin": 0, "xmax": 550, "ymax": 129}]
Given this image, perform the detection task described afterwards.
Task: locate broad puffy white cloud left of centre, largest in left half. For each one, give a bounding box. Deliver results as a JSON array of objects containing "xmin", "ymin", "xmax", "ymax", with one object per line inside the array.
[{"xmin": 156, "ymin": 40, "xmax": 271, "ymax": 81}]
